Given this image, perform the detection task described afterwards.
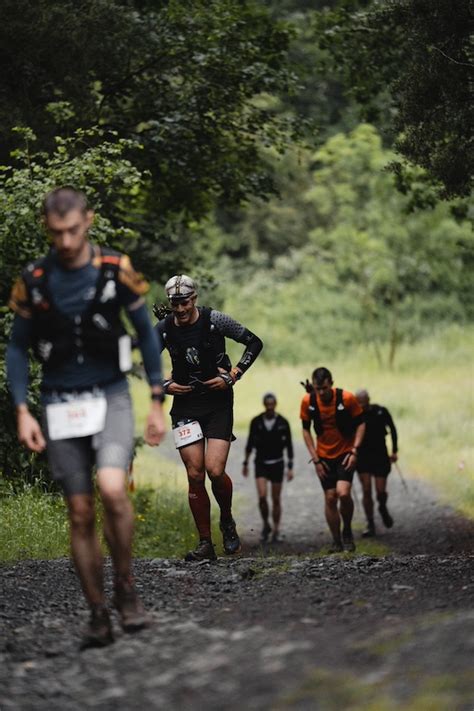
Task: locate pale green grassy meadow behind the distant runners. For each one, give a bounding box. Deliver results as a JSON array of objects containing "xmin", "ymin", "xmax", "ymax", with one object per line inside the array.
[{"xmin": 133, "ymin": 326, "xmax": 474, "ymax": 516}]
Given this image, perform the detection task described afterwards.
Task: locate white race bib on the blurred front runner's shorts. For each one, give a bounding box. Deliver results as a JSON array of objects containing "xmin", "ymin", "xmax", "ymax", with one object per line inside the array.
[{"xmin": 46, "ymin": 395, "xmax": 107, "ymax": 440}]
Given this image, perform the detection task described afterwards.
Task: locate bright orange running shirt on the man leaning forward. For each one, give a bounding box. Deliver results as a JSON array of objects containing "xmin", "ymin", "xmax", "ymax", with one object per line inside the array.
[{"xmin": 300, "ymin": 388, "xmax": 362, "ymax": 459}]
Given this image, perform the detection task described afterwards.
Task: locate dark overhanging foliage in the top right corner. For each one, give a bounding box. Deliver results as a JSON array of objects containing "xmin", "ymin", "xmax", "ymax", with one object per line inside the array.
[{"xmin": 314, "ymin": 0, "xmax": 474, "ymax": 197}]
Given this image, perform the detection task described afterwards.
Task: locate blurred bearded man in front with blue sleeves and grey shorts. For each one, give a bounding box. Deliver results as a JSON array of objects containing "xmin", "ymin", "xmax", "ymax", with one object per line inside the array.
[{"xmin": 7, "ymin": 187, "xmax": 165, "ymax": 647}]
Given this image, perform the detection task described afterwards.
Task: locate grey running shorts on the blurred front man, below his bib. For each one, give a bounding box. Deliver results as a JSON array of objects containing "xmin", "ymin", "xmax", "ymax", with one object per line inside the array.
[{"xmin": 43, "ymin": 384, "xmax": 134, "ymax": 496}]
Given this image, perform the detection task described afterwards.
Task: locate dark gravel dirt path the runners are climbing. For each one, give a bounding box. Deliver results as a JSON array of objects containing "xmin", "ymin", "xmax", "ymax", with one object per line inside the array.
[{"xmin": 0, "ymin": 441, "xmax": 474, "ymax": 711}]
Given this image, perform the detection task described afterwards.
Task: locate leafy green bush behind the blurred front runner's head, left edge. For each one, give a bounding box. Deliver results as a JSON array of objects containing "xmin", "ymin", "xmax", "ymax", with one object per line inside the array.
[{"xmin": 0, "ymin": 128, "xmax": 142, "ymax": 481}]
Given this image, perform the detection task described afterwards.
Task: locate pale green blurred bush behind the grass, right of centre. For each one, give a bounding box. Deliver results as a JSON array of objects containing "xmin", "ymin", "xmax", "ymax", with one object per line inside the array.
[{"xmin": 214, "ymin": 125, "xmax": 474, "ymax": 365}]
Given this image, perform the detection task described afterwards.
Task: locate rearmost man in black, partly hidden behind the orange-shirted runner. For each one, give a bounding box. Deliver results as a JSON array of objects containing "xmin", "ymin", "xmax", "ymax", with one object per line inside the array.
[{"xmin": 356, "ymin": 390, "xmax": 398, "ymax": 538}]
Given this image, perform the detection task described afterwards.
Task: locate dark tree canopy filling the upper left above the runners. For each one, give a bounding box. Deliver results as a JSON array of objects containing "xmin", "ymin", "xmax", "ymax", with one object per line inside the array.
[{"xmin": 0, "ymin": 0, "xmax": 296, "ymax": 279}]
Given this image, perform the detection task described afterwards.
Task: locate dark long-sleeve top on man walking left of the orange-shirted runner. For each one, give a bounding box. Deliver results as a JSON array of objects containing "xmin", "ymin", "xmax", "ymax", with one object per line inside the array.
[{"xmin": 245, "ymin": 413, "xmax": 293, "ymax": 469}]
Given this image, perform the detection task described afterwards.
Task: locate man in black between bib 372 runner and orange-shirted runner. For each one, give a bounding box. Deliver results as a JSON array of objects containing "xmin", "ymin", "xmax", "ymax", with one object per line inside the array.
[{"xmin": 242, "ymin": 393, "xmax": 293, "ymax": 543}]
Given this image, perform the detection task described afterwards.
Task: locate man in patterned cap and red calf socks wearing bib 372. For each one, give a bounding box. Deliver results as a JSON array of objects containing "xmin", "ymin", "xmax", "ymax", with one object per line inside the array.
[{"xmin": 156, "ymin": 274, "xmax": 262, "ymax": 561}]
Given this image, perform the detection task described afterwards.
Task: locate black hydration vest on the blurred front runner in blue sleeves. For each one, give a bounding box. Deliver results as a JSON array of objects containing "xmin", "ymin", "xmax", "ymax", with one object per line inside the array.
[{"xmin": 22, "ymin": 247, "xmax": 126, "ymax": 368}]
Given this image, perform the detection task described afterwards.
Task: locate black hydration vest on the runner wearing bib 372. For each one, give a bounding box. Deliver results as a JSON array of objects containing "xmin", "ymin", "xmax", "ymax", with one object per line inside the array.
[{"xmin": 163, "ymin": 306, "xmax": 232, "ymax": 385}]
